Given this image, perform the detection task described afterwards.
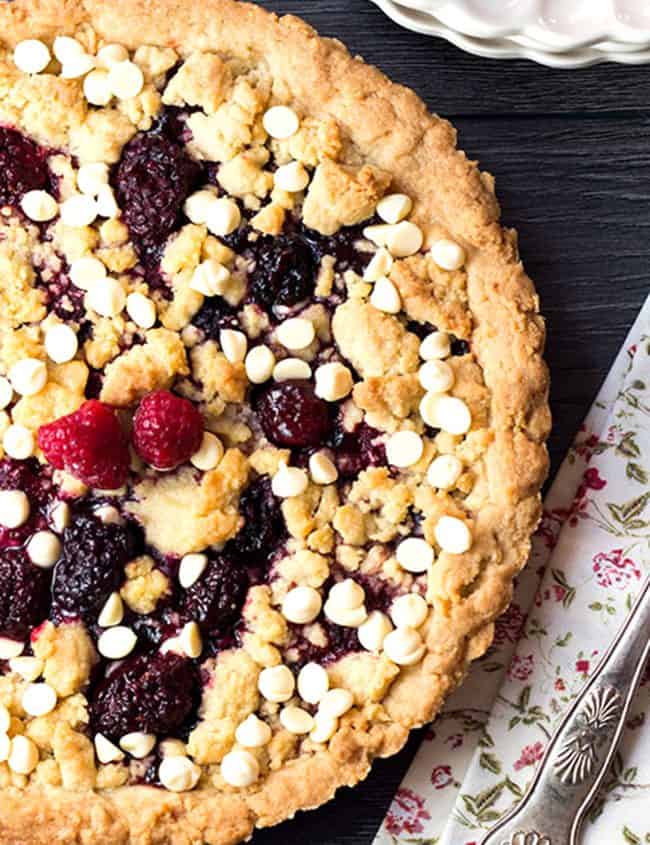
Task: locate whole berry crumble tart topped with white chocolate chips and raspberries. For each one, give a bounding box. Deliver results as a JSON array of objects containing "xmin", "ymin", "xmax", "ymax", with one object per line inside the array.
[{"xmin": 0, "ymin": 0, "xmax": 549, "ymax": 845}]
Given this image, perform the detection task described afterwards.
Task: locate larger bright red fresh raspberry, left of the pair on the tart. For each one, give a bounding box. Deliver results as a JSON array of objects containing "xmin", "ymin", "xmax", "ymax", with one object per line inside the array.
[{"xmin": 38, "ymin": 399, "xmax": 129, "ymax": 490}]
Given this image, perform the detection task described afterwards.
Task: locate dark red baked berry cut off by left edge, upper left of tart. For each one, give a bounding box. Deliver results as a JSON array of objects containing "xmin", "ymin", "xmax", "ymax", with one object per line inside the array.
[{"xmin": 0, "ymin": 126, "xmax": 56, "ymax": 205}]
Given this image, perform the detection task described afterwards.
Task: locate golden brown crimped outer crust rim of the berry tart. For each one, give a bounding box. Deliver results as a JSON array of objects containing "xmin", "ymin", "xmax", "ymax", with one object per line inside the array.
[{"xmin": 0, "ymin": 0, "xmax": 550, "ymax": 845}]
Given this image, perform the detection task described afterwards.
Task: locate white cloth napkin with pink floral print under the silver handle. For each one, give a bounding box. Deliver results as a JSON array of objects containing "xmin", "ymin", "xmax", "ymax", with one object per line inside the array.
[{"xmin": 374, "ymin": 298, "xmax": 650, "ymax": 845}]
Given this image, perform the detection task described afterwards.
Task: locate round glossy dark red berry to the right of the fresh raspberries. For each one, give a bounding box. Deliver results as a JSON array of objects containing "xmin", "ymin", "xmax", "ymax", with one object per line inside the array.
[{"xmin": 254, "ymin": 381, "xmax": 331, "ymax": 448}]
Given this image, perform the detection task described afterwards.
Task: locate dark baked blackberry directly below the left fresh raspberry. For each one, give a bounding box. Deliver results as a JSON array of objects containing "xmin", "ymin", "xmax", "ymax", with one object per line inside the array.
[{"xmin": 52, "ymin": 515, "xmax": 141, "ymax": 624}]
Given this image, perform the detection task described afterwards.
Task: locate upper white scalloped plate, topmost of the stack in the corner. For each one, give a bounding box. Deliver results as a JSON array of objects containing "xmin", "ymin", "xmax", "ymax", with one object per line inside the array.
[{"xmin": 392, "ymin": 0, "xmax": 650, "ymax": 50}]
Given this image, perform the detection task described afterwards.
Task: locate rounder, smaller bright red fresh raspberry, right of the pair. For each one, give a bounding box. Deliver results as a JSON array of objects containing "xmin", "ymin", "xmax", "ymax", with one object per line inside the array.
[{"xmin": 133, "ymin": 390, "xmax": 203, "ymax": 469}]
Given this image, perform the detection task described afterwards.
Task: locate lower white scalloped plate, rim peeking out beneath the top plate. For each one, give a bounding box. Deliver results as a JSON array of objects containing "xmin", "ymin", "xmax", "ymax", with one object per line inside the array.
[{"xmin": 372, "ymin": 0, "xmax": 650, "ymax": 68}]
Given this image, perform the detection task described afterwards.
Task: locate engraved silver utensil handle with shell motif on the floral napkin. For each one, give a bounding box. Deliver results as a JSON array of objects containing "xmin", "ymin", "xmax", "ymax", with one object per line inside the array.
[{"xmin": 482, "ymin": 578, "xmax": 650, "ymax": 845}]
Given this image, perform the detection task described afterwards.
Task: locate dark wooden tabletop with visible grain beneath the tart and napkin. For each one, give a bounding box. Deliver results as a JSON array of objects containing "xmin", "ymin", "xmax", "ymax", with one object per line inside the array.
[{"xmin": 253, "ymin": 0, "xmax": 650, "ymax": 845}]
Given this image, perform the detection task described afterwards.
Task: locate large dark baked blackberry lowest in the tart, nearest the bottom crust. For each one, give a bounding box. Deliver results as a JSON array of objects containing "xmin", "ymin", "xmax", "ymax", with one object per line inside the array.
[{"xmin": 91, "ymin": 652, "xmax": 199, "ymax": 741}]
